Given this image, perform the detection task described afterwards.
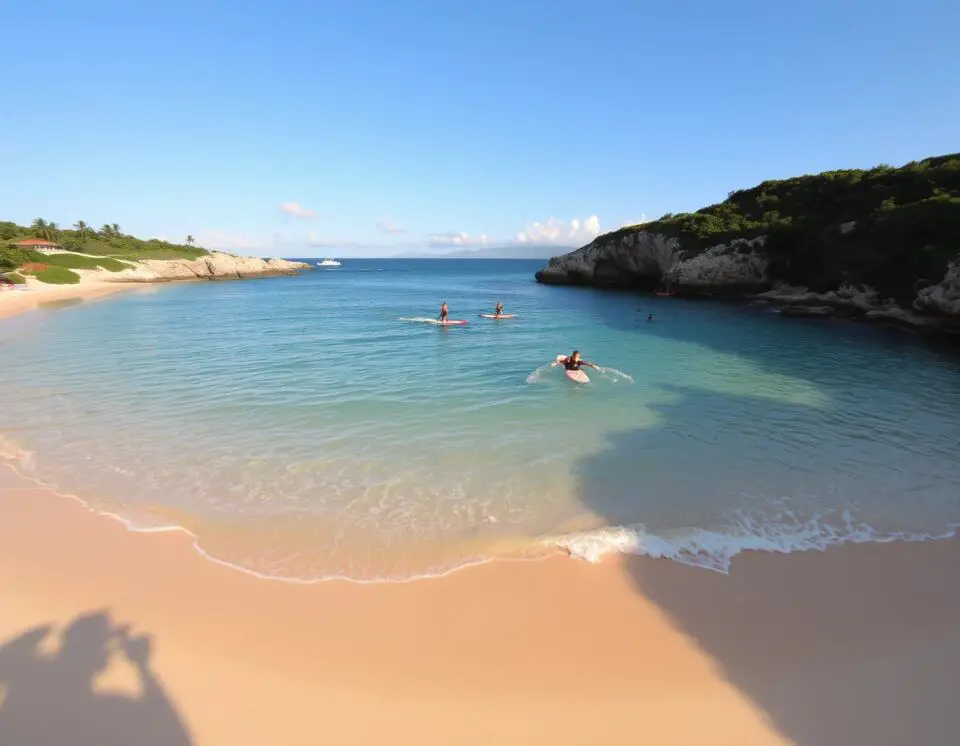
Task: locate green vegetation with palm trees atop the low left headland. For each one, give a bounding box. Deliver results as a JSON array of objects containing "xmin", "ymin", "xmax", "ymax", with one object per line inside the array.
[{"xmin": 0, "ymin": 218, "xmax": 209, "ymax": 260}]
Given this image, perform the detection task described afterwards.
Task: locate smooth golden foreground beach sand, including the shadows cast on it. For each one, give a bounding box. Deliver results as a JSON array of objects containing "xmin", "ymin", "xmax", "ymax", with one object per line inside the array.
[{"xmin": 0, "ymin": 467, "xmax": 960, "ymax": 746}]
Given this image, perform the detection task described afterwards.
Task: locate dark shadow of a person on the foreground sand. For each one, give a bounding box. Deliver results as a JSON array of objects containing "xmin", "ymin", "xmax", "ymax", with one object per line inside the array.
[{"xmin": 0, "ymin": 611, "xmax": 192, "ymax": 746}]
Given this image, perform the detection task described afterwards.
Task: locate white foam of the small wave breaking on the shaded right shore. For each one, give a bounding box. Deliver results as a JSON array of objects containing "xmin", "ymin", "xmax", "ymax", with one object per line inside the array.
[{"xmin": 544, "ymin": 511, "xmax": 960, "ymax": 574}]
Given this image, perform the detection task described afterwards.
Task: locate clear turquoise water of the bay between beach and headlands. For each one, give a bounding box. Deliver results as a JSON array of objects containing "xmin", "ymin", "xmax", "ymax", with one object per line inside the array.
[{"xmin": 0, "ymin": 260, "xmax": 960, "ymax": 580}]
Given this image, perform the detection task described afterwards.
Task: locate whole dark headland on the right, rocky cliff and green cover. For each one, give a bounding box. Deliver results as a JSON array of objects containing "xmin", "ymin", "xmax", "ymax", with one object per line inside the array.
[{"xmin": 536, "ymin": 153, "xmax": 960, "ymax": 329}]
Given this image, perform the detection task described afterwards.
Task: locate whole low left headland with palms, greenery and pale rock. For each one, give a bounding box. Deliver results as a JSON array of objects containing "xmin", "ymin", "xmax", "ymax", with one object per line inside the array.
[{"xmin": 0, "ymin": 218, "xmax": 309, "ymax": 287}]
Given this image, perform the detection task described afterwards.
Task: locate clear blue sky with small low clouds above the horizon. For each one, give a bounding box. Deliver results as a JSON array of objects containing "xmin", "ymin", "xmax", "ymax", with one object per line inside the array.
[{"xmin": 0, "ymin": 0, "xmax": 960, "ymax": 256}]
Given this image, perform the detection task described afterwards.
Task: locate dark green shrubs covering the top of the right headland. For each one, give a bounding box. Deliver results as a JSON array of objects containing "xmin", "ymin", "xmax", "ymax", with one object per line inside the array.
[{"xmin": 616, "ymin": 153, "xmax": 960, "ymax": 304}]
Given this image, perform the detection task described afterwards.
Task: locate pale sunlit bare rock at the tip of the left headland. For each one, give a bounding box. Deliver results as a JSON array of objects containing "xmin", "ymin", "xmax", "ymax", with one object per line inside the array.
[{"xmin": 74, "ymin": 251, "xmax": 312, "ymax": 282}]
